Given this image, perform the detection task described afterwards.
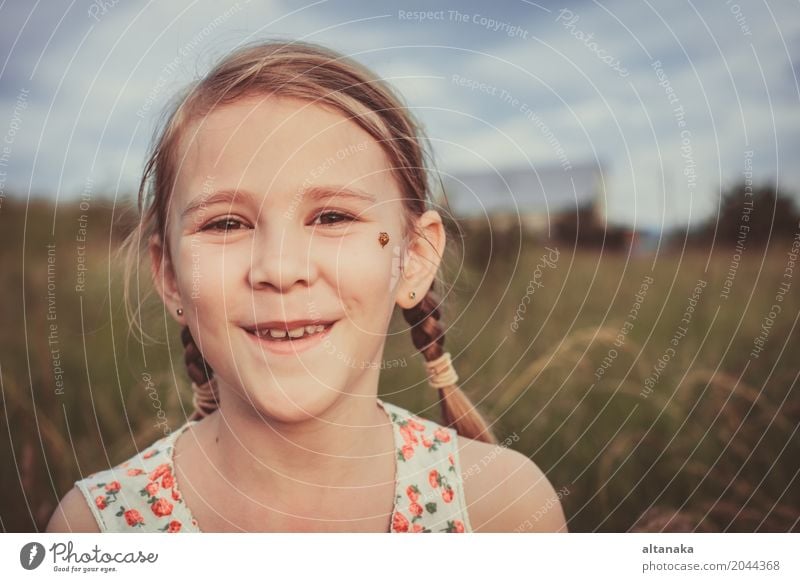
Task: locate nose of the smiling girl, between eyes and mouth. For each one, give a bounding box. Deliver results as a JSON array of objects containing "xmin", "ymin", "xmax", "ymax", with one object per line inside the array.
[{"xmin": 248, "ymin": 221, "xmax": 317, "ymax": 293}]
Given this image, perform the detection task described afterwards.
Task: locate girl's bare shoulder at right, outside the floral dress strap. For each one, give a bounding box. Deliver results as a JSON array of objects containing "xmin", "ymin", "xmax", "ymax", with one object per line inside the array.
[{"xmin": 457, "ymin": 435, "xmax": 567, "ymax": 532}]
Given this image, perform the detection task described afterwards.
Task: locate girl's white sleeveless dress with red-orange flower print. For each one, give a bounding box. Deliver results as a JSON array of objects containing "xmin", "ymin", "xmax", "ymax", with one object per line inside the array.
[{"xmin": 75, "ymin": 399, "xmax": 472, "ymax": 533}]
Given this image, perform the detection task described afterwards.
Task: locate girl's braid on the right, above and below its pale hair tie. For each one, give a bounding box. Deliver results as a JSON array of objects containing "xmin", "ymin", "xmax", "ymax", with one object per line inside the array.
[{"xmin": 403, "ymin": 285, "xmax": 497, "ymax": 444}]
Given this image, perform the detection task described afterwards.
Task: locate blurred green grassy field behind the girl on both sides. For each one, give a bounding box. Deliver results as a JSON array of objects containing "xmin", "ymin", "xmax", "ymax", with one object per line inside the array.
[{"xmin": 0, "ymin": 199, "xmax": 800, "ymax": 532}]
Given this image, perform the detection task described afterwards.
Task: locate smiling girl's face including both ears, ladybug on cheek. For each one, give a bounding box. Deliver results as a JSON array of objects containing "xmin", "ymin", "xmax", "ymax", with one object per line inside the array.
[{"xmin": 151, "ymin": 97, "xmax": 444, "ymax": 421}]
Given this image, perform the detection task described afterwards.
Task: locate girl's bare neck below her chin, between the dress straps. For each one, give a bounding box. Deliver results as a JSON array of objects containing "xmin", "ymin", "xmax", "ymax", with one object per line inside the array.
[{"xmin": 209, "ymin": 383, "xmax": 394, "ymax": 498}]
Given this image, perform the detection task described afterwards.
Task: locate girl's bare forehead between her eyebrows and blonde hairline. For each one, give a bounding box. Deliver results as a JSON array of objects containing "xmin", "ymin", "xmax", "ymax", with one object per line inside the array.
[{"xmin": 176, "ymin": 97, "xmax": 399, "ymax": 204}]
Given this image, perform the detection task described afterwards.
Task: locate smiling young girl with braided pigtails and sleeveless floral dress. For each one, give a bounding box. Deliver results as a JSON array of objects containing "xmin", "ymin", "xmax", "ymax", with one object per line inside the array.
[{"xmin": 48, "ymin": 42, "xmax": 566, "ymax": 532}]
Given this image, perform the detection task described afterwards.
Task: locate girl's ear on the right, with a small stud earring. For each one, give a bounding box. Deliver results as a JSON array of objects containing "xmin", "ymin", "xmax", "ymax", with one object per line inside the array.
[{"xmin": 395, "ymin": 210, "xmax": 447, "ymax": 309}]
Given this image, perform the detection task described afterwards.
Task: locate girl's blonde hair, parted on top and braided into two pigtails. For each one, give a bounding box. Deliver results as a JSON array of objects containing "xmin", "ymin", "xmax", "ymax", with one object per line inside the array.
[{"xmin": 122, "ymin": 41, "xmax": 496, "ymax": 443}]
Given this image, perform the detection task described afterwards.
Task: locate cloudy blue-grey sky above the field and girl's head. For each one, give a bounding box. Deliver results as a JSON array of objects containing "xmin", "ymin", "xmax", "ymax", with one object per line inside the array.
[{"xmin": 0, "ymin": 0, "xmax": 800, "ymax": 230}]
